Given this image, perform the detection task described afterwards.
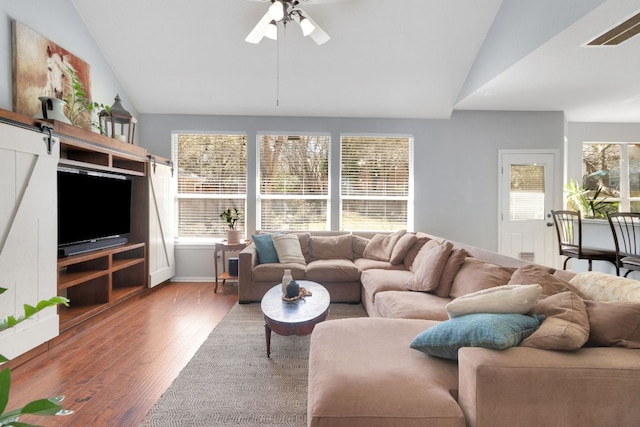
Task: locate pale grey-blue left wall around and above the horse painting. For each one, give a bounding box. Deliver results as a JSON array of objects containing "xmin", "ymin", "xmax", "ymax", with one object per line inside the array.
[{"xmin": 0, "ymin": 0, "xmax": 138, "ymax": 125}]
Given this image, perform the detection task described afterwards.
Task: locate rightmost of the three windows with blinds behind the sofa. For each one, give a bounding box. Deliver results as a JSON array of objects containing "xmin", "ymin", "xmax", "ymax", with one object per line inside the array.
[{"xmin": 340, "ymin": 136, "xmax": 413, "ymax": 230}]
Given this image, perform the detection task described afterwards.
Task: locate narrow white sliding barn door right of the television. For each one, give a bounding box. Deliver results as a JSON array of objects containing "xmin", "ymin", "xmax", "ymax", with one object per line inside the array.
[{"xmin": 148, "ymin": 161, "xmax": 176, "ymax": 287}]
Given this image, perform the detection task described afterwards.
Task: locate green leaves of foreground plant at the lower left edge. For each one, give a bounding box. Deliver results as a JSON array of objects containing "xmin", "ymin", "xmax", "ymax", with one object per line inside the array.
[{"xmin": 0, "ymin": 288, "xmax": 73, "ymax": 426}]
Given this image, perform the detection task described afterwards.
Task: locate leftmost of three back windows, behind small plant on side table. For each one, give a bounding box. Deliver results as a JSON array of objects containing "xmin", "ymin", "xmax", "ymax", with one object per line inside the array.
[{"xmin": 172, "ymin": 134, "xmax": 247, "ymax": 238}]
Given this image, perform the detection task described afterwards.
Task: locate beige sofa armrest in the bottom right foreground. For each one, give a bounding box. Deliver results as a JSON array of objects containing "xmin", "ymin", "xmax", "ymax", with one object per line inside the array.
[{"xmin": 458, "ymin": 347, "xmax": 640, "ymax": 427}]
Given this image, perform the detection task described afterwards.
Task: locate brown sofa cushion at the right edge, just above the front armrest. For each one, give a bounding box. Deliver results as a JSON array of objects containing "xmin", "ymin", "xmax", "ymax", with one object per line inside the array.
[{"xmin": 585, "ymin": 300, "xmax": 640, "ymax": 349}]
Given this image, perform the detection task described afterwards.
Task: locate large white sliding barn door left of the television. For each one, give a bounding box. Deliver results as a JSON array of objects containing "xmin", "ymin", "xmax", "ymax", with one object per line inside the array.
[{"xmin": 0, "ymin": 123, "xmax": 60, "ymax": 359}]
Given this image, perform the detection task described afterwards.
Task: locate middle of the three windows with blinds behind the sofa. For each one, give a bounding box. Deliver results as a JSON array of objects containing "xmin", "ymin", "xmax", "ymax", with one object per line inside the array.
[{"xmin": 258, "ymin": 135, "xmax": 330, "ymax": 230}]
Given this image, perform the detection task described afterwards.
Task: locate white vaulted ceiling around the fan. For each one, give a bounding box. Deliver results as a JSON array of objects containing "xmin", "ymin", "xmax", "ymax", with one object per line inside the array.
[{"xmin": 72, "ymin": 0, "xmax": 640, "ymax": 122}]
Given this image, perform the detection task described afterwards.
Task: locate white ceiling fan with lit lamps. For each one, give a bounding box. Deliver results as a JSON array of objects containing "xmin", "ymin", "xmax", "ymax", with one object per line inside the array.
[{"xmin": 245, "ymin": 0, "xmax": 331, "ymax": 45}]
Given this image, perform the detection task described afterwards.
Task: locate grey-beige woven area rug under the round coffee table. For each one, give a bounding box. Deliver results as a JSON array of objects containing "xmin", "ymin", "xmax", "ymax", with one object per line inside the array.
[{"xmin": 140, "ymin": 304, "xmax": 366, "ymax": 427}]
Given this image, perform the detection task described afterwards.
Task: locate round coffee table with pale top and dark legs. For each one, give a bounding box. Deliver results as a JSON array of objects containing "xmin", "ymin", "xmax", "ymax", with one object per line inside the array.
[{"xmin": 260, "ymin": 280, "xmax": 330, "ymax": 357}]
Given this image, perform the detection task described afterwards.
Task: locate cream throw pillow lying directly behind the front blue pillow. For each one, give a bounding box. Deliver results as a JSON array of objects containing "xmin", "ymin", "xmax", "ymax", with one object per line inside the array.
[{"xmin": 445, "ymin": 285, "xmax": 542, "ymax": 318}]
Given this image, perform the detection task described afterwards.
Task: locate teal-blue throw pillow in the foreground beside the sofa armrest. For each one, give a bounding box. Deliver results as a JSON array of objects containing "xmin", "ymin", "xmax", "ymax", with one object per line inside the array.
[{"xmin": 409, "ymin": 313, "xmax": 544, "ymax": 360}]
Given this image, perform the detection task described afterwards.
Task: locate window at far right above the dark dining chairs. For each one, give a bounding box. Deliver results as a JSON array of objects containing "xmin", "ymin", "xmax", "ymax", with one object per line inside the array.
[{"xmin": 582, "ymin": 143, "xmax": 640, "ymax": 212}]
